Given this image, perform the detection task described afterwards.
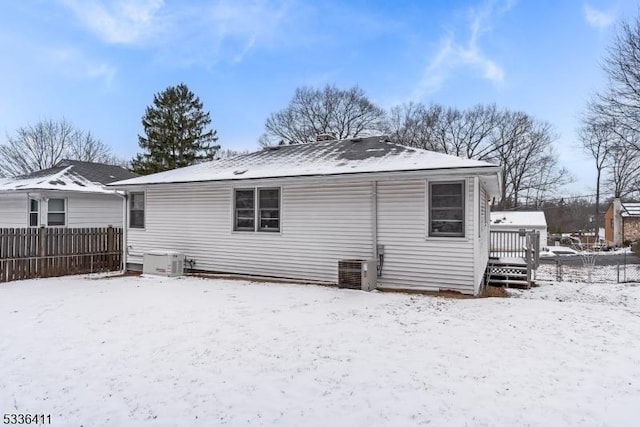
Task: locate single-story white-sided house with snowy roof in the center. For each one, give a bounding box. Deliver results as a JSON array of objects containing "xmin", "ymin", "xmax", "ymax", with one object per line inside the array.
[{"xmin": 110, "ymin": 137, "xmax": 500, "ymax": 295}]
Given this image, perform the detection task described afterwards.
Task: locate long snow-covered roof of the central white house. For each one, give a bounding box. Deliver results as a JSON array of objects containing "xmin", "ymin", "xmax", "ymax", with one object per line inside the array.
[{"xmin": 111, "ymin": 137, "xmax": 498, "ymax": 186}]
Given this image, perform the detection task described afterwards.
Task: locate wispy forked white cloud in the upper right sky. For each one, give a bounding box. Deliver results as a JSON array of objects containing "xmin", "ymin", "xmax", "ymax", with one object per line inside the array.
[{"xmin": 411, "ymin": 1, "xmax": 514, "ymax": 101}]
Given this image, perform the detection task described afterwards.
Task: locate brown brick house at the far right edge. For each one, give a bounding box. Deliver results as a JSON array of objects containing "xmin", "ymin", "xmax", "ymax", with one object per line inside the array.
[{"xmin": 604, "ymin": 199, "xmax": 640, "ymax": 246}]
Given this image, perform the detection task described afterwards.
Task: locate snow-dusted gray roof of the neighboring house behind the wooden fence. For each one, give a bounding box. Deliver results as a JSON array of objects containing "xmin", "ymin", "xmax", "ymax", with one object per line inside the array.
[{"xmin": 0, "ymin": 160, "xmax": 137, "ymax": 193}]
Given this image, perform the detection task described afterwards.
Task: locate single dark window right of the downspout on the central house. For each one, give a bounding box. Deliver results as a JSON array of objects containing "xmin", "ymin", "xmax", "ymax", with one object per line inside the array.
[{"xmin": 429, "ymin": 182, "xmax": 464, "ymax": 237}]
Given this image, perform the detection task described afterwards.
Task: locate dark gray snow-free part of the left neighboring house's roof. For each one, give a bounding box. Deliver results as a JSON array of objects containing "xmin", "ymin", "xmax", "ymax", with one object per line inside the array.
[{"xmin": 16, "ymin": 159, "xmax": 138, "ymax": 184}]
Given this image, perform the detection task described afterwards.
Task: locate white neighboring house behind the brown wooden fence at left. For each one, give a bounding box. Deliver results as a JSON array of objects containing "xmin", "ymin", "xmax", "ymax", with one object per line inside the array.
[{"xmin": 0, "ymin": 160, "xmax": 137, "ymax": 228}]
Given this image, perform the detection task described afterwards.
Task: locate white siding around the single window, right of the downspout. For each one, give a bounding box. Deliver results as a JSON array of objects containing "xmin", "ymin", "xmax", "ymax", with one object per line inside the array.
[{"xmin": 378, "ymin": 179, "xmax": 477, "ymax": 293}]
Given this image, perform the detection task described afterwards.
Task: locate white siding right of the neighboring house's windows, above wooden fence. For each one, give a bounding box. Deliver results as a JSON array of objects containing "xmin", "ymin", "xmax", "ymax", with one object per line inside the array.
[{"xmin": 65, "ymin": 193, "xmax": 123, "ymax": 227}]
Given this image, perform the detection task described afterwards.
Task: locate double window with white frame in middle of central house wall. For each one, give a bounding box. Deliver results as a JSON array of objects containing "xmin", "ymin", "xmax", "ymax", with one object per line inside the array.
[{"xmin": 233, "ymin": 188, "xmax": 280, "ymax": 232}]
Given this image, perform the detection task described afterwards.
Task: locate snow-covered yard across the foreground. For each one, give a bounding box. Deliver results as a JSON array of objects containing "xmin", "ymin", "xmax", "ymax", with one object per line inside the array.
[{"xmin": 0, "ymin": 277, "xmax": 640, "ymax": 426}]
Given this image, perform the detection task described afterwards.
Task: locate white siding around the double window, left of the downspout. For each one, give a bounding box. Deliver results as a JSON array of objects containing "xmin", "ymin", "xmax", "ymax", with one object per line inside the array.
[{"xmin": 129, "ymin": 183, "xmax": 373, "ymax": 282}]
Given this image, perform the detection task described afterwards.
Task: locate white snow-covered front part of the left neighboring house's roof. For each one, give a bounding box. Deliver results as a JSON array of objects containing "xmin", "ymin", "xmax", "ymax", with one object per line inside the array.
[{"xmin": 0, "ymin": 166, "xmax": 115, "ymax": 194}]
